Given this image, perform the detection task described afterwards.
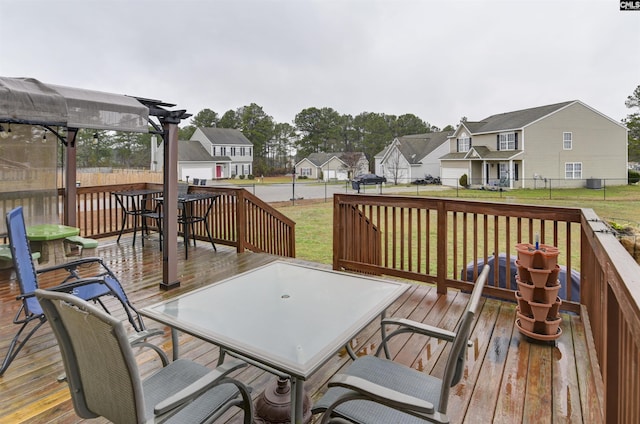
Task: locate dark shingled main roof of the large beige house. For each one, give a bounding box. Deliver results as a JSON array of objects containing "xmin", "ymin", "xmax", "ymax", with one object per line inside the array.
[{"xmin": 461, "ymin": 100, "xmax": 577, "ymax": 134}]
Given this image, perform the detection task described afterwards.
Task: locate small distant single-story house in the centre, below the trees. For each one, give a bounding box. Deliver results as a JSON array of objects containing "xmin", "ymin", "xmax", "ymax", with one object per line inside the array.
[{"xmin": 295, "ymin": 152, "xmax": 369, "ymax": 181}]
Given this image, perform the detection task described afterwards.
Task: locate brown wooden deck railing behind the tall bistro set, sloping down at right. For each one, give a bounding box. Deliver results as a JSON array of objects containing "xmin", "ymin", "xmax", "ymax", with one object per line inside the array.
[{"xmin": 0, "ymin": 183, "xmax": 295, "ymax": 257}]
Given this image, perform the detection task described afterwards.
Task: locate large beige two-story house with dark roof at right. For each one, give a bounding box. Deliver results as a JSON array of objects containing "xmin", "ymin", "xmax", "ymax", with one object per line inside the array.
[{"xmin": 440, "ymin": 100, "xmax": 627, "ymax": 188}]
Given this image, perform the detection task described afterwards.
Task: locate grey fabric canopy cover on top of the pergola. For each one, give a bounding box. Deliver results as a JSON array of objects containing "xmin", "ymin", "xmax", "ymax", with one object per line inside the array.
[{"xmin": 0, "ymin": 77, "xmax": 149, "ymax": 132}]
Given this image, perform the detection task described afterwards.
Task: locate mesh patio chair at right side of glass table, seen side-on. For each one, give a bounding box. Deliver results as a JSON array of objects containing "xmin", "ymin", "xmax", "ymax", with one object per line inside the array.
[{"xmin": 312, "ymin": 265, "xmax": 490, "ymax": 424}]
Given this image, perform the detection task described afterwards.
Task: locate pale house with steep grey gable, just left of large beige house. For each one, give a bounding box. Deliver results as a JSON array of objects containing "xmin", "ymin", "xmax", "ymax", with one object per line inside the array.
[{"xmin": 374, "ymin": 131, "xmax": 451, "ymax": 184}]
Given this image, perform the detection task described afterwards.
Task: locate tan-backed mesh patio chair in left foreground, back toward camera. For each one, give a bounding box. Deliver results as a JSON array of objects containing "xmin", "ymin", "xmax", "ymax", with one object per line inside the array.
[{"xmin": 36, "ymin": 290, "xmax": 253, "ymax": 424}]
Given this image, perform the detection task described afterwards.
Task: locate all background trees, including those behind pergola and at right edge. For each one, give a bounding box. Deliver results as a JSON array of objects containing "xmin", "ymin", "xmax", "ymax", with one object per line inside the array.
[{"xmin": 71, "ymin": 85, "xmax": 640, "ymax": 175}]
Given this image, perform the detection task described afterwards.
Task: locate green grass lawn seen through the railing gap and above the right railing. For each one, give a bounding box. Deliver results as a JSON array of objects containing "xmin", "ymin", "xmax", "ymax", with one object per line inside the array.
[{"xmin": 278, "ymin": 186, "xmax": 640, "ymax": 264}]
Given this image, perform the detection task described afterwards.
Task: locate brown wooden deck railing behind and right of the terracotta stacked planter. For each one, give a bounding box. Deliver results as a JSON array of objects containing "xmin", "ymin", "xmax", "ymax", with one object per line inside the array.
[{"xmin": 333, "ymin": 194, "xmax": 640, "ymax": 422}]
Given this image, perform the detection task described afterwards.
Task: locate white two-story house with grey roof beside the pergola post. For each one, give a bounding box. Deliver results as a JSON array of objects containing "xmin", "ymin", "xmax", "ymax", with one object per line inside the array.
[{"xmin": 158, "ymin": 128, "xmax": 253, "ymax": 180}]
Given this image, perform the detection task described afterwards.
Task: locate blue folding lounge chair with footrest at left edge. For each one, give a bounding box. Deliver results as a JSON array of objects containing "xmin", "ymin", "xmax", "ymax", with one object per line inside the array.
[{"xmin": 0, "ymin": 206, "xmax": 163, "ymax": 376}]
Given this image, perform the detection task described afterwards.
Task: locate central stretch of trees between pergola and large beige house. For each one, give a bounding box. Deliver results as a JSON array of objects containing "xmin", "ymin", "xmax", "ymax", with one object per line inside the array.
[{"xmin": 180, "ymin": 103, "xmax": 453, "ymax": 175}]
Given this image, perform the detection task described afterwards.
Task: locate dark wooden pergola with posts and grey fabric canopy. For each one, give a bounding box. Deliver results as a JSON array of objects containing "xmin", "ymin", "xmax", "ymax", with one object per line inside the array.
[{"xmin": 0, "ymin": 77, "xmax": 191, "ymax": 289}]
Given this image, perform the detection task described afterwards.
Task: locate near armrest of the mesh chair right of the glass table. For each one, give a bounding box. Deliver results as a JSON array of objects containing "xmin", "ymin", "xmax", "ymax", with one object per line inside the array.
[{"xmin": 327, "ymin": 374, "xmax": 436, "ymax": 414}]
